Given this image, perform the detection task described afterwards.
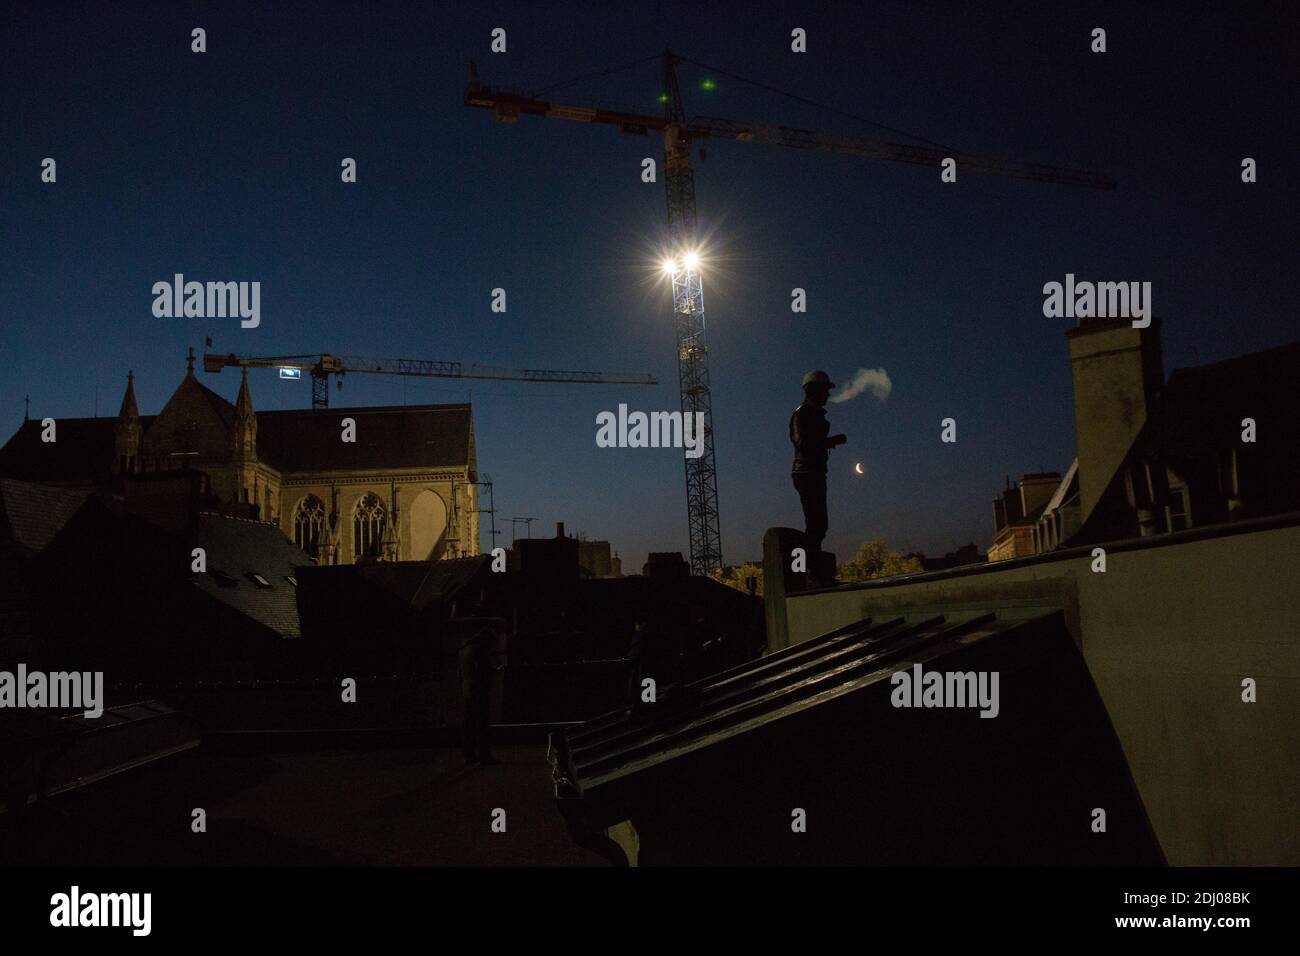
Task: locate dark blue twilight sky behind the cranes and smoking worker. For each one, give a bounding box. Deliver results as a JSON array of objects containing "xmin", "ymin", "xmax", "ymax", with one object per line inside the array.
[{"xmin": 0, "ymin": 3, "xmax": 1300, "ymax": 568}]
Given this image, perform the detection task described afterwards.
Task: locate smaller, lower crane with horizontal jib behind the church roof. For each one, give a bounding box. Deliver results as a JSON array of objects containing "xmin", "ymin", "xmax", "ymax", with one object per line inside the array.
[{"xmin": 203, "ymin": 352, "xmax": 659, "ymax": 408}]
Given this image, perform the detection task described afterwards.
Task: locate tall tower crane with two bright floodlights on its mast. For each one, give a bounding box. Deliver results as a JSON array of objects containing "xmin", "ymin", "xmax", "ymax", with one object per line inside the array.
[{"xmin": 465, "ymin": 51, "xmax": 1115, "ymax": 574}]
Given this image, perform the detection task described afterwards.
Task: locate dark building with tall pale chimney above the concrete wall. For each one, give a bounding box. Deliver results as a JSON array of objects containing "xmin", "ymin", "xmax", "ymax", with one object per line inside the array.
[{"xmin": 988, "ymin": 319, "xmax": 1300, "ymax": 561}]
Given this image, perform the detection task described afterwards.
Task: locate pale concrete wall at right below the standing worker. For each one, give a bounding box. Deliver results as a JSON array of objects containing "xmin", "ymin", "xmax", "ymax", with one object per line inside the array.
[{"xmin": 769, "ymin": 516, "xmax": 1300, "ymax": 865}]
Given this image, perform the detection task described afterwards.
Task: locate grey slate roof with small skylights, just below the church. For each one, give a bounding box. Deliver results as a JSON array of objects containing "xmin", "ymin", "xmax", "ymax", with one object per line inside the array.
[{"xmin": 192, "ymin": 512, "xmax": 312, "ymax": 637}]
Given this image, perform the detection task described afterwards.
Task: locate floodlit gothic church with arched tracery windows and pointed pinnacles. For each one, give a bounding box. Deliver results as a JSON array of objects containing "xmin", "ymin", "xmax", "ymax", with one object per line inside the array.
[{"xmin": 0, "ymin": 350, "xmax": 478, "ymax": 564}]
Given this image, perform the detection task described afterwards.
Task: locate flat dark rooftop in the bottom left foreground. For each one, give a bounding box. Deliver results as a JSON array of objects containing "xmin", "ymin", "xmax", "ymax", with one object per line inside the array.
[{"xmin": 0, "ymin": 745, "xmax": 605, "ymax": 866}]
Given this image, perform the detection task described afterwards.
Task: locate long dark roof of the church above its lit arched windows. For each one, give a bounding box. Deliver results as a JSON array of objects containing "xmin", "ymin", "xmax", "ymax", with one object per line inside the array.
[{"xmin": 257, "ymin": 405, "xmax": 472, "ymax": 473}]
